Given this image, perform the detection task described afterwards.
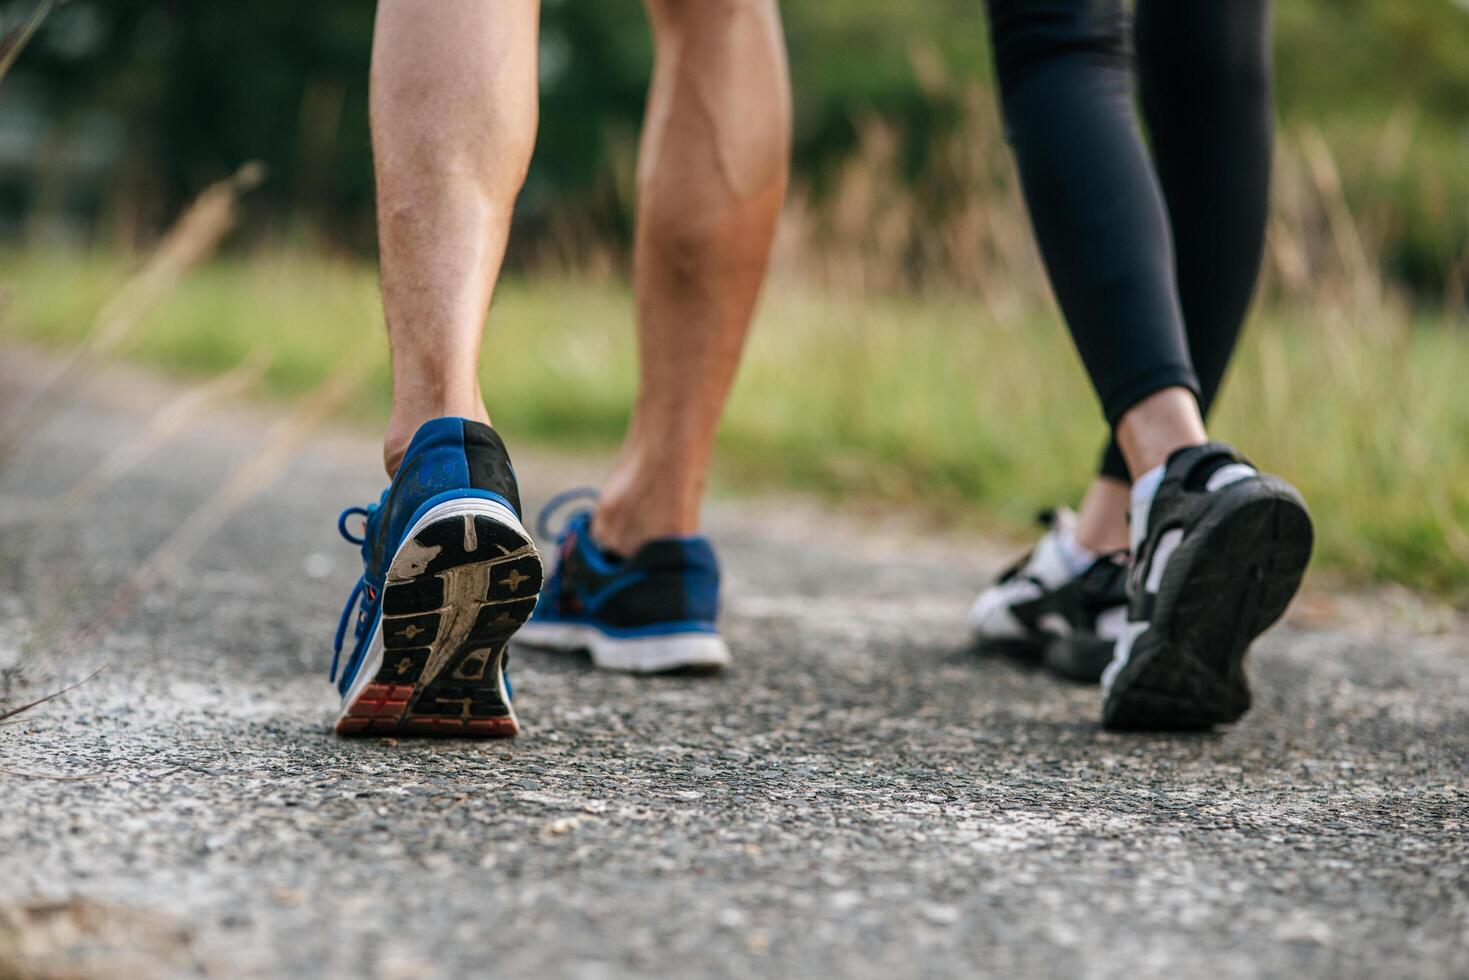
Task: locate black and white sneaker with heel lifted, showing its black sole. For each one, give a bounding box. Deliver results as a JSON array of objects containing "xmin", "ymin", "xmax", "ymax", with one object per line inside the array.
[{"xmin": 1102, "ymin": 442, "xmax": 1312, "ymax": 730}]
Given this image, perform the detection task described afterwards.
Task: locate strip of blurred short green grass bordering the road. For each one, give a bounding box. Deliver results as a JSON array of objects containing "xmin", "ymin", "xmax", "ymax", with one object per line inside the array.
[{"xmin": 0, "ymin": 253, "xmax": 1469, "ymax": 602}]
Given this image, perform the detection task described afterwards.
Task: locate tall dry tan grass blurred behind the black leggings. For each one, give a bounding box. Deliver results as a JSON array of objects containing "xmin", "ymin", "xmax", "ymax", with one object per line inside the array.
[{"xmin": 774, "ymin": 50, "xmax": 1451, "ymax": 345}]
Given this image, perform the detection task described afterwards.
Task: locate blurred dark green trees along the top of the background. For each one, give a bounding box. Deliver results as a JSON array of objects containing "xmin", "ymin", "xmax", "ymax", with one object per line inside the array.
[{"xmin": 0, "ymin": 0, "xmax": 1469, "ymax": 299}]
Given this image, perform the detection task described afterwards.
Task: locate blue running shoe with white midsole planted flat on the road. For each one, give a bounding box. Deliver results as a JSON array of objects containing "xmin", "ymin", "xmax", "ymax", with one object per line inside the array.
[{"xmin": 516, "ymin": 491, "xmax": 730, "ymax": 673}]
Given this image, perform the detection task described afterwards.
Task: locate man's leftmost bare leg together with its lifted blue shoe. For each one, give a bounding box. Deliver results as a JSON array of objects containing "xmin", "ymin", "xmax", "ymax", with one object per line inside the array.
[{"xmin": 331, "ymin": 0, "xmax": 542, "ymax": 738}]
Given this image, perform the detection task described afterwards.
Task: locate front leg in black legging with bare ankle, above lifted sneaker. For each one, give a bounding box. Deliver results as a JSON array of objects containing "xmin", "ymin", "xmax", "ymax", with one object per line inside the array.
[{"xmin": 989, "ymin": 0, "xmax": 1203, "ymax": 473}]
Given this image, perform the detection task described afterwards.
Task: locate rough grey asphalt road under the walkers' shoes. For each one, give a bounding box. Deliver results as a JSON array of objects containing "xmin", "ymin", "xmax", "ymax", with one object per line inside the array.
[{"xmin": 0, "ymin": 351, "xmax": 1469, "ymax": 979}]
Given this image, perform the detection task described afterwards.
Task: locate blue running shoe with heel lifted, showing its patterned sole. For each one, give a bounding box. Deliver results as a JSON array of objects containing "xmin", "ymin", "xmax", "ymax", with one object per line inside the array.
[{"xmin": 332, "ymin": 419, "xmax": 541, "ymax": 738}]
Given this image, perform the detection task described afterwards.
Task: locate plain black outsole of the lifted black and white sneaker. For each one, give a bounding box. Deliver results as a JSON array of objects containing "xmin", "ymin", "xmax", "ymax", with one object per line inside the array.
[{"xmin": 1102, "ymin": 476, "xmax": 1313, "ymax": 732}]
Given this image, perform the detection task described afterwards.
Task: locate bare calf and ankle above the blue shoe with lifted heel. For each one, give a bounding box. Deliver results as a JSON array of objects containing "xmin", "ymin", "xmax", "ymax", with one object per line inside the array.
[{"xmin": 372, "ymin": 0, "xmax": 539, "ymax": 476}]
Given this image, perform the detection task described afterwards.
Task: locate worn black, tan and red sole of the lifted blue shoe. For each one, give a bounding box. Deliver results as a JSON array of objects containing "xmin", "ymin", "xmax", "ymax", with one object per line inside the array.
[{"xmin": 336, "ymin": 497, "xmax": 542, "ymax": 738}]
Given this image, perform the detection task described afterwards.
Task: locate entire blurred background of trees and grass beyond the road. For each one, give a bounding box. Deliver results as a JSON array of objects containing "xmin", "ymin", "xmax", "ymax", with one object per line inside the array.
[{"xmin": 0, "ymin": 0, "xmax": 1469, "ymax": 602}]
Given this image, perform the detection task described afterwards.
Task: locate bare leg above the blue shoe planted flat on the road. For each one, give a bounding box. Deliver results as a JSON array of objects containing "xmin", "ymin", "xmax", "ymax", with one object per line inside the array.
[{"xmin": 593, "ymin": 0, "xmax": 790, "ymax": 555}]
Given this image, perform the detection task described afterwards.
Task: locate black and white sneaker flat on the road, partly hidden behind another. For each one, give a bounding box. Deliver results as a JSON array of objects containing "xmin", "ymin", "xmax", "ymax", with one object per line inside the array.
[{"xmin": 970, "ymin": 507, "xmax": 1127, "ymax": 683}]
